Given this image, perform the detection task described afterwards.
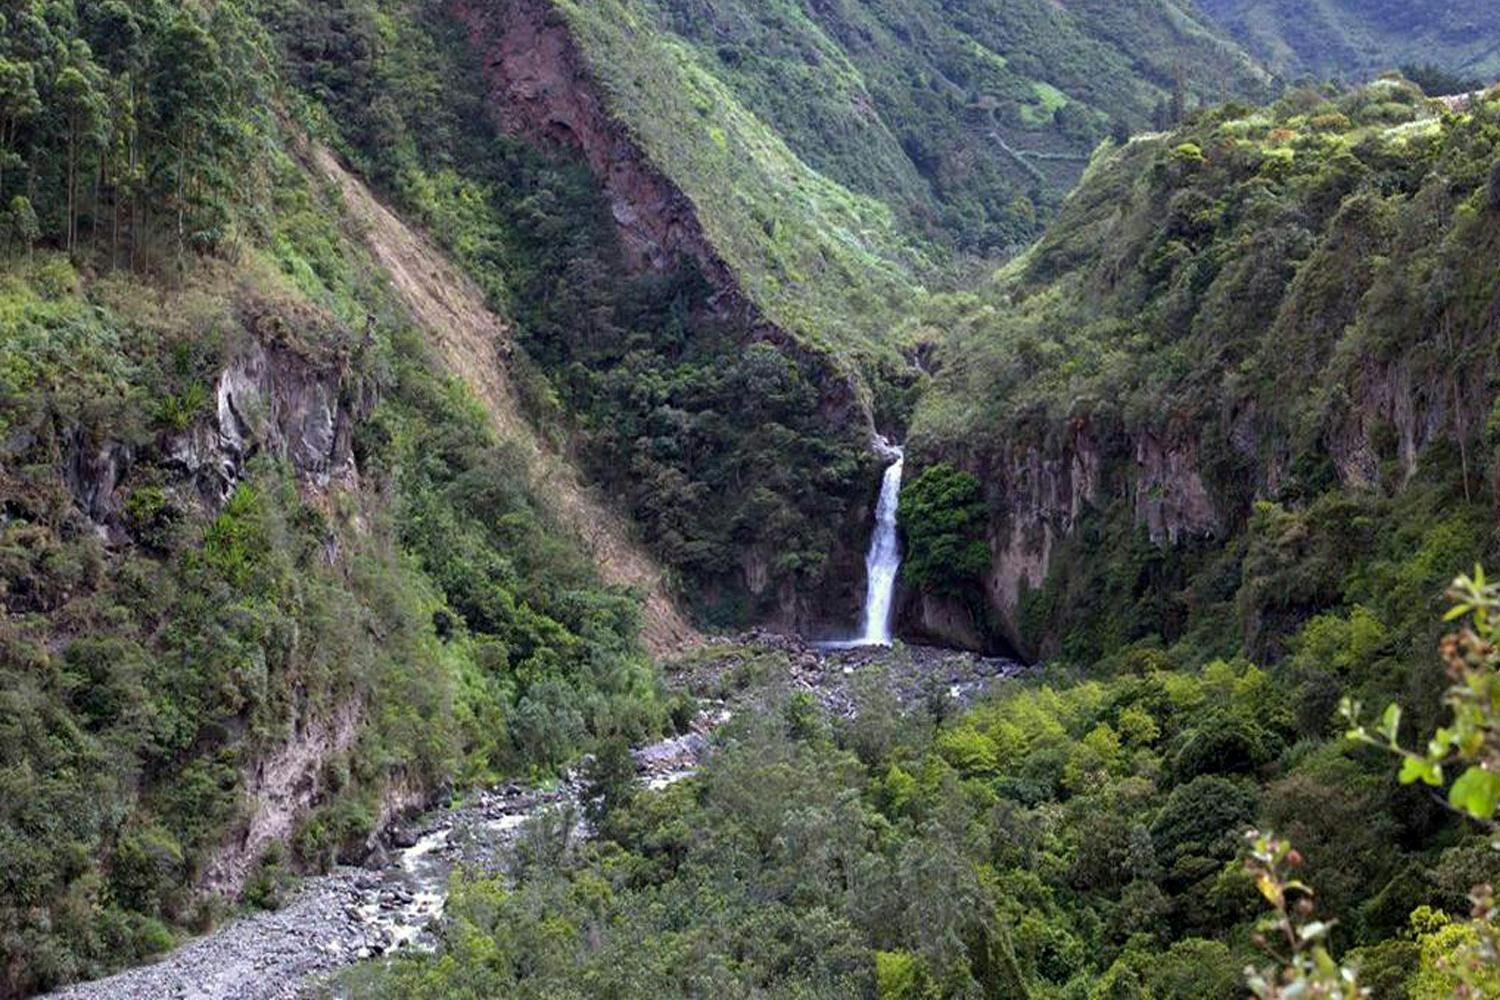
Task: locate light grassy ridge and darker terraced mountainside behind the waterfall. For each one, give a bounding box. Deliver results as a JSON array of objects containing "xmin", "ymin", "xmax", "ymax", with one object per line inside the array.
[{"xmin": 546, "ymin": 0, "xmax": 1265, "ymax": 332}]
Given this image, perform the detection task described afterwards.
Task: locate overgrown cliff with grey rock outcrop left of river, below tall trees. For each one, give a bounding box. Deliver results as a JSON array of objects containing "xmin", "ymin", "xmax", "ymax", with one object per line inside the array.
[{"xmin": 0, "ymin": 139, "xmax": 669, "ymax": 996}]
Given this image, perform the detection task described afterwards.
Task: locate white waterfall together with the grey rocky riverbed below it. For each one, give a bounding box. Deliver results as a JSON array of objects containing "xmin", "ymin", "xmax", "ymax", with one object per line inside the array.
[{"xmin": 51, "ymin": 436, "xmax": 1023, "ymax": 1000}]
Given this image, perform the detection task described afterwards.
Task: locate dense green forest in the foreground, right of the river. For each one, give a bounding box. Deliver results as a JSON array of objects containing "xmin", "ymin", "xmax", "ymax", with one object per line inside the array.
[{"xmin": 348, "ymin": 617, "xmax": 1496, "ymax": 1000}]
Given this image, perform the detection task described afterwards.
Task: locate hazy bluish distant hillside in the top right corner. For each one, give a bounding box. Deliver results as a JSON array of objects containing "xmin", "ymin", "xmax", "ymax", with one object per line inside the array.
[{"xmin": 1199, "ymin": 0, "xmax": 1500, "ymax": 81}]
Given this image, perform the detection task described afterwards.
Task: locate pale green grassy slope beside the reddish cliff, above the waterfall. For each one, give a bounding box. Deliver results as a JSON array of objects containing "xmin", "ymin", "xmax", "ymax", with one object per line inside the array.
[{"xmin": 546, "ymin": 0, "xmax": 932, "ymax": 355}]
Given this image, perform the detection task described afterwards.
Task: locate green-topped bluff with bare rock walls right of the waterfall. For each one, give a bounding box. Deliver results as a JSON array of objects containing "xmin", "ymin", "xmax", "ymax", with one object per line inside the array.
[{"xmin": 908, "ymin": 81, "xmax": 1500, "ymax": 657}]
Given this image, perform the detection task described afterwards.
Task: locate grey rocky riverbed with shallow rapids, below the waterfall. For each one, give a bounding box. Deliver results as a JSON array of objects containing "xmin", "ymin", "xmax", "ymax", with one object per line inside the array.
[{"xmin": 51, "ymin": 633, "xmax": 1025, "ymax": 1000}]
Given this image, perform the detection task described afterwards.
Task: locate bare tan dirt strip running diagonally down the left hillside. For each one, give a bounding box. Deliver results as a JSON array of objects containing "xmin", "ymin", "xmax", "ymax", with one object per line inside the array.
[{"xmin": 312, "ymin": 147, "xmax": 701, "ymax": 654}]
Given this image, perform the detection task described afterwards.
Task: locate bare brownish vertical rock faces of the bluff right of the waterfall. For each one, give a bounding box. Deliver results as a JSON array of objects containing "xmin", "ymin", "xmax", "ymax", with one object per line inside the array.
[{"xmin": 903, "ymin": 344, "xmax": 1487, "ymax": 657}]
